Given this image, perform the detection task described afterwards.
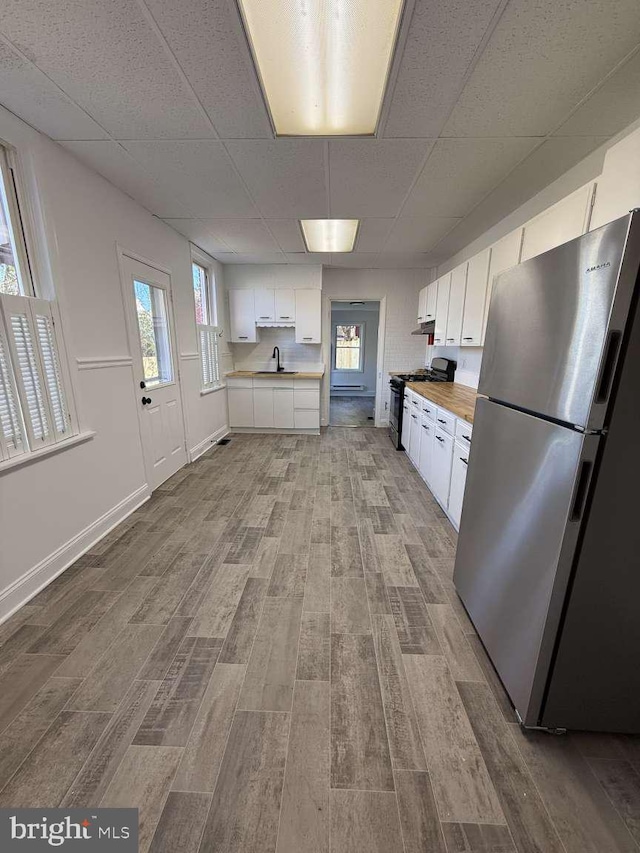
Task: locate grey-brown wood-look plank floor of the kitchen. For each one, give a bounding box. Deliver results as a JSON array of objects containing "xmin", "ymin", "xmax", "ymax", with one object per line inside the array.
[{"xmin": 0, "ymin": 429, "xmax": 640, "ymax": 853}]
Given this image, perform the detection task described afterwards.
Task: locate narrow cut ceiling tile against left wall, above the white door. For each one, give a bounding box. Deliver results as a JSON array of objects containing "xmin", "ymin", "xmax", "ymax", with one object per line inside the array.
[{"xmin": 60, "ymin": 141, "xmax": 189, "ymax": 217}]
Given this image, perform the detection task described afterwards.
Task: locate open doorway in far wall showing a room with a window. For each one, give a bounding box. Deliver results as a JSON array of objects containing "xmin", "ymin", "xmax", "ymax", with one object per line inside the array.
[{"xmin": 329, "ymin": 300, "xmax": 380, "ymax": 427}]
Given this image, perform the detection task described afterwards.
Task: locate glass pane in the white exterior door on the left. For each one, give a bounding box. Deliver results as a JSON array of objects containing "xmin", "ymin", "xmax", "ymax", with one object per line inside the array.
[{"xmin": 133, "ymin": 281, "xmax": 173, "ymax": 388}]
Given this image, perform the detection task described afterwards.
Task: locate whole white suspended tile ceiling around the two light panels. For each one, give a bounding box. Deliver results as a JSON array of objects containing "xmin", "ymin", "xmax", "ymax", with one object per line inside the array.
[{"xmin": 0, "ymin": 0, "xmax": 640, "ymax": 268}]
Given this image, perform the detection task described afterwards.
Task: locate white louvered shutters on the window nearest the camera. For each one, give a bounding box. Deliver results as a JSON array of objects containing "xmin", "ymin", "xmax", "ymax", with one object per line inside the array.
[{"xmin": 0, "ymin": 295, "xmax": 71, "ymax": 450}]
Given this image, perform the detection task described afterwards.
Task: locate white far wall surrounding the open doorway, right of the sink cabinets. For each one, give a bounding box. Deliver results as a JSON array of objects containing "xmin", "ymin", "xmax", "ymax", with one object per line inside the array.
[{"xmin": 322, "ymin": 267, "xmax": 430, "ymax": 422}]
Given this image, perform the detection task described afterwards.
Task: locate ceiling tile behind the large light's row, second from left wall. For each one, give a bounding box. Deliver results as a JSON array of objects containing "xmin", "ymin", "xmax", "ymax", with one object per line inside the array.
[{"xmin": 123, "ymin": 139, "xmax": 257, "ymax": 219}]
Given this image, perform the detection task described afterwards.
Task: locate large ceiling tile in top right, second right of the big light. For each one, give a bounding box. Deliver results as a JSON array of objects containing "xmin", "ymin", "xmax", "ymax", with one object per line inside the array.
[{"xmin": 443, "ymin": 0, "xmax": 640, "ymax": 136}]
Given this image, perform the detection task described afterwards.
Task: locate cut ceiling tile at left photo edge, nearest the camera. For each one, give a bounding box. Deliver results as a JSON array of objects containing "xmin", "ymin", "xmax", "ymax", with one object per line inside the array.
[{"xmin": 0, "ymin": 40, "xmax": 107, "ymax": 139}]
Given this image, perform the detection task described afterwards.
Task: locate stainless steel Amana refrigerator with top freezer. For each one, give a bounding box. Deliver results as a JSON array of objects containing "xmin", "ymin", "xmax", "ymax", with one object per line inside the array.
[{"xmin": 454, "ymin": 211, "xmax": 640, "ymax": 732}]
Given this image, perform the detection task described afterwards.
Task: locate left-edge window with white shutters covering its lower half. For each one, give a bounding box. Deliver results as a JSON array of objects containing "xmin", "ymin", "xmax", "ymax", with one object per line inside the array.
[{"xmin": 0, "ymin": 143, "xmax": 74, "ymax": 462}]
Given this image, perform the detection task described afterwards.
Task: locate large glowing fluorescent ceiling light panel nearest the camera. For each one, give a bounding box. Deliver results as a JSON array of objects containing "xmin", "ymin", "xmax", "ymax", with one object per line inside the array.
[{"xmin": 237, "ymin": 0, "xmax": 404, "ymax": 136}]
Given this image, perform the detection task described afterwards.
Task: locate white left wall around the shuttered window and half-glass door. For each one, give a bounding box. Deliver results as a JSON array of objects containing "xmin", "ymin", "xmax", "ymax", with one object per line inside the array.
[{"xmin": 0, "ymin": 109, "xmax": 227, "ymax": 618}]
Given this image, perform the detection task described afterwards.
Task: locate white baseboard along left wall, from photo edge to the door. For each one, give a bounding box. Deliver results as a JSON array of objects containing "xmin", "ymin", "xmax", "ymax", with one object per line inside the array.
[{"xmin": 0, "ymin": 483, "xmax": 151, "ymax": 624}]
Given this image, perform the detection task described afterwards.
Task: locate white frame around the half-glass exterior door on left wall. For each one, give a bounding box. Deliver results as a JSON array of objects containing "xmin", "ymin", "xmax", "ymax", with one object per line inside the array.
[{"xmin": 116, "ymin": 243, "xmax": 189, "ymax": 493}]
